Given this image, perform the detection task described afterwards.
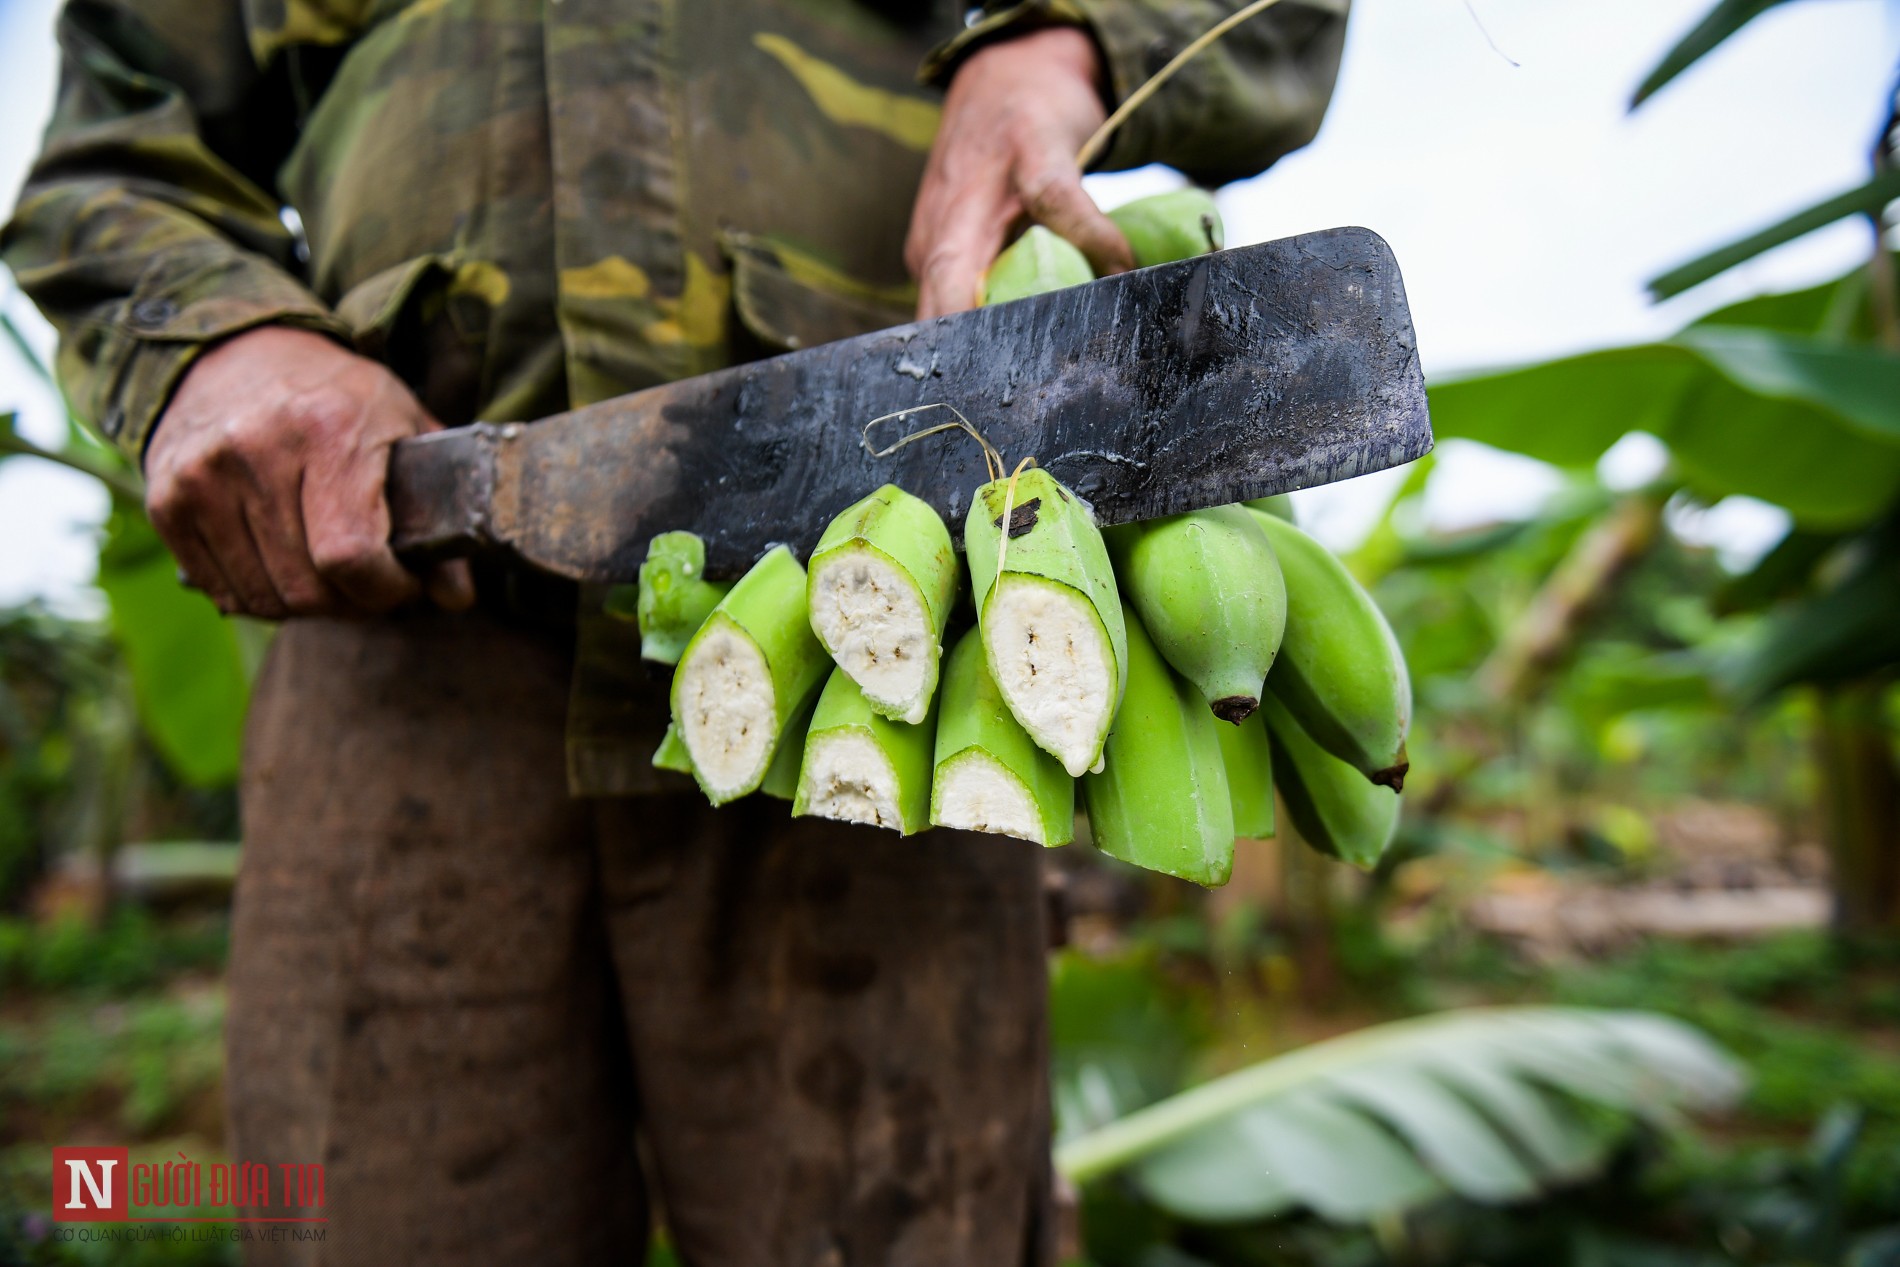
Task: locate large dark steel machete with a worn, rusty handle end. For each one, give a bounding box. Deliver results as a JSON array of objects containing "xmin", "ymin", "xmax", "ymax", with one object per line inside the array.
[{"xmin": 390, "ymin": 228, "xmax": 1433, "ymax": 581}]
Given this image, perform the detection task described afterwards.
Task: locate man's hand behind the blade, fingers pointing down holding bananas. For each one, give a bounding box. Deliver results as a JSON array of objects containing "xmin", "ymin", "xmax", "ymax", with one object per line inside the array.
[{"xmin": 904, "ymin": 27, "xmax": 1134, "ymax": 319}]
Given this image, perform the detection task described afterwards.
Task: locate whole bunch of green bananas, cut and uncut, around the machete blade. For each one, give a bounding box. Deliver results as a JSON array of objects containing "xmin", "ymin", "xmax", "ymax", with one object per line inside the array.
[{"xmin": 638, "ymin": 190, "xmax": 1412, "ymax": 885}]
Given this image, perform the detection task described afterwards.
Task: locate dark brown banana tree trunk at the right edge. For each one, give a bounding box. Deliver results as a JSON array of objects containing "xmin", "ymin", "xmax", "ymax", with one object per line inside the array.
[{"xmin": 1815, "ymin": 680, "xmax": 1900, "ymax": 936}]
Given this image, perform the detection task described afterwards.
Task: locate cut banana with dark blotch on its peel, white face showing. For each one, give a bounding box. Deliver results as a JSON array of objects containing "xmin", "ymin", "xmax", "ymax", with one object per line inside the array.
[{"xmin": 963, "ymin": 469, "xmax": 1129, "ymax": 777}]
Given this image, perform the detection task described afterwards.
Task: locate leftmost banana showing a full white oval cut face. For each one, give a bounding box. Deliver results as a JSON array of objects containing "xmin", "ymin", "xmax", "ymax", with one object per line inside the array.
[{"xmin": 673, "ymin": 545, "xmax": 830, "ymax": 805}]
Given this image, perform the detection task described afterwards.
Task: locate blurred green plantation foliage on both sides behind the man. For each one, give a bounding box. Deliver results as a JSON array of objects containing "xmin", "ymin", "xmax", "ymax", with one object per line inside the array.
[{"xmin": 0, "ymin": 0, "xmax": 1900, "ymax": 1267}]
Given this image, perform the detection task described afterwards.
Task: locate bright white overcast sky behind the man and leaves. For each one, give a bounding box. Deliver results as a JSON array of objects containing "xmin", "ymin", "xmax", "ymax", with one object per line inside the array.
[{"xmin": 0, "ymin": 0, "xmax": 1900, "ymax": 608}]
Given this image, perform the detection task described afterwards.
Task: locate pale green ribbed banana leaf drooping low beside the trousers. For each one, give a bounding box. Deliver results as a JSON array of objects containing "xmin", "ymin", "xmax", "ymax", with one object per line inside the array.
[{"xmin": 1056, "ymin": 1007, "xmax": 1742, "ymax": 1223}]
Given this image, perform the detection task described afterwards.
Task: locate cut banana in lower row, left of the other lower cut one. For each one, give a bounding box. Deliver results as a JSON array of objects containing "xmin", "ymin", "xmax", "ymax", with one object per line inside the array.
[{"xmin": 792, "ymin": 669, "xmax": 935, "ymax": 836}]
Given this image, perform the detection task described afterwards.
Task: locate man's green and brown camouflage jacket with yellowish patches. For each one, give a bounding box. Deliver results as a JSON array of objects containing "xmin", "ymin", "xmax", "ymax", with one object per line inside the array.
[{"xmin": 11, "ymin": 0, "xmax": 1345, "ymax": 792}]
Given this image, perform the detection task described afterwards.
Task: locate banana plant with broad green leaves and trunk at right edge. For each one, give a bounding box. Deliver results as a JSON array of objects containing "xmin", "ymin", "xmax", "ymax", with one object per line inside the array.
[{"xmin": 1431, "ymin": 0, "xmax": 1900, "ymax": 935}]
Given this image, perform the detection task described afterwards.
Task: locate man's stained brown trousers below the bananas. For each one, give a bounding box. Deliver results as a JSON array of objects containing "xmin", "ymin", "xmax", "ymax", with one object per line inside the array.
[{"xmin": 228, "ymin": 615, "xmax": 1049, "ymax": 1267}]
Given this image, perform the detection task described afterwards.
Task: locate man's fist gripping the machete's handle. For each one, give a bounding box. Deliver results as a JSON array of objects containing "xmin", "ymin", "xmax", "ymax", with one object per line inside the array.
[{"xmin": 144, "ymin": 327, "xmax": 475, "ymax": 619}]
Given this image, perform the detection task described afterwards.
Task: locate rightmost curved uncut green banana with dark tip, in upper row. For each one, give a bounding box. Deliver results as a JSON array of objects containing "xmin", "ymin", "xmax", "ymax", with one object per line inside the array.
[{"xmin": 1254, "ymin": 511, "xmax": 1412, "ymax": 792}]
